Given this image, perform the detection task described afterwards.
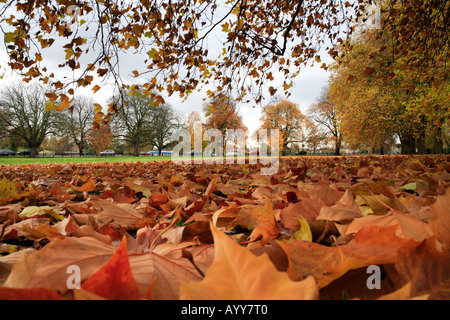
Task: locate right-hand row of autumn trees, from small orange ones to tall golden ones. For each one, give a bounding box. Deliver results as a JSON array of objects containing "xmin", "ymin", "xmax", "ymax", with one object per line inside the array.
[{"xmin": 255, "ymin": 1, "xmax": 450, "ymax": 154}]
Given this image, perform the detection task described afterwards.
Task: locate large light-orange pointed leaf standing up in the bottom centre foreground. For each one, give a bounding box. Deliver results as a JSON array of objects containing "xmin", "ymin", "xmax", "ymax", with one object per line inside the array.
[{"xmin": 180, "ymin": 224, "xmax": 319, "ymax": 300}]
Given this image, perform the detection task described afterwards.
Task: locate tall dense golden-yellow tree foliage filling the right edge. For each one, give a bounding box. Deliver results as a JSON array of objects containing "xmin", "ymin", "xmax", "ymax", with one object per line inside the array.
[{"xmin": 326, "ymin": 1, "xmax": 450, "ymax": 154}]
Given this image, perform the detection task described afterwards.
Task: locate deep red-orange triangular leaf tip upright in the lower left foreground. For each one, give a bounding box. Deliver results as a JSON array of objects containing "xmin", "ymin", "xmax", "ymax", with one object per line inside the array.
[{"xmin": 82, "ymin": 237, "xmax": 140, "ymax": 300}]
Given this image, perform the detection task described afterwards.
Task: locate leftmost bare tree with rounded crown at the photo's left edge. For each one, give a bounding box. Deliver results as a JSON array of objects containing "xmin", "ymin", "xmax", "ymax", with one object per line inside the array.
[{"xmin": 0, "ymin": 83, "xmax": 56, "ymax": 158}]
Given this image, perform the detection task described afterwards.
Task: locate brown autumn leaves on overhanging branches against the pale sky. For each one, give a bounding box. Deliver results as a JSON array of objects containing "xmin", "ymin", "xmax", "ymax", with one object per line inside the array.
[{"xmin": 0, "ymin": 0, "xmax": 372, "ymax": 115}]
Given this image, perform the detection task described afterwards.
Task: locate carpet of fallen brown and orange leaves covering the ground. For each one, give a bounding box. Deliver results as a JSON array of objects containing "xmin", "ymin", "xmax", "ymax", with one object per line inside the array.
[{"xmin": 0, "ymin": 155, "xmax": 450, "ymax": 300}]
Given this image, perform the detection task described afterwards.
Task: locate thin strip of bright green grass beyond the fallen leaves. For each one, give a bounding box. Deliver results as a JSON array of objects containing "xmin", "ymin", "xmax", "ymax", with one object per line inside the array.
[{"xmin": 0, "ymin": 156, "xmax": 171, "ymax": 165}]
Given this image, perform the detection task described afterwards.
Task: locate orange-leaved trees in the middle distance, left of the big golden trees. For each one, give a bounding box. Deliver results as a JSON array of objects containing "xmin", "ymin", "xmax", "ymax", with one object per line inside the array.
[{"xmin": 181, "ymin": 92, "xmax": 342, "ymax": 155}]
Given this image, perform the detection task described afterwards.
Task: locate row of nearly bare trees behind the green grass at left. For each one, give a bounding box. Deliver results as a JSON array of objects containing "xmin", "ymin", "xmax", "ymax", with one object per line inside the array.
[{"xmin": 0, "ymin": 83, "xmax": 180, "ymax": 157}]
